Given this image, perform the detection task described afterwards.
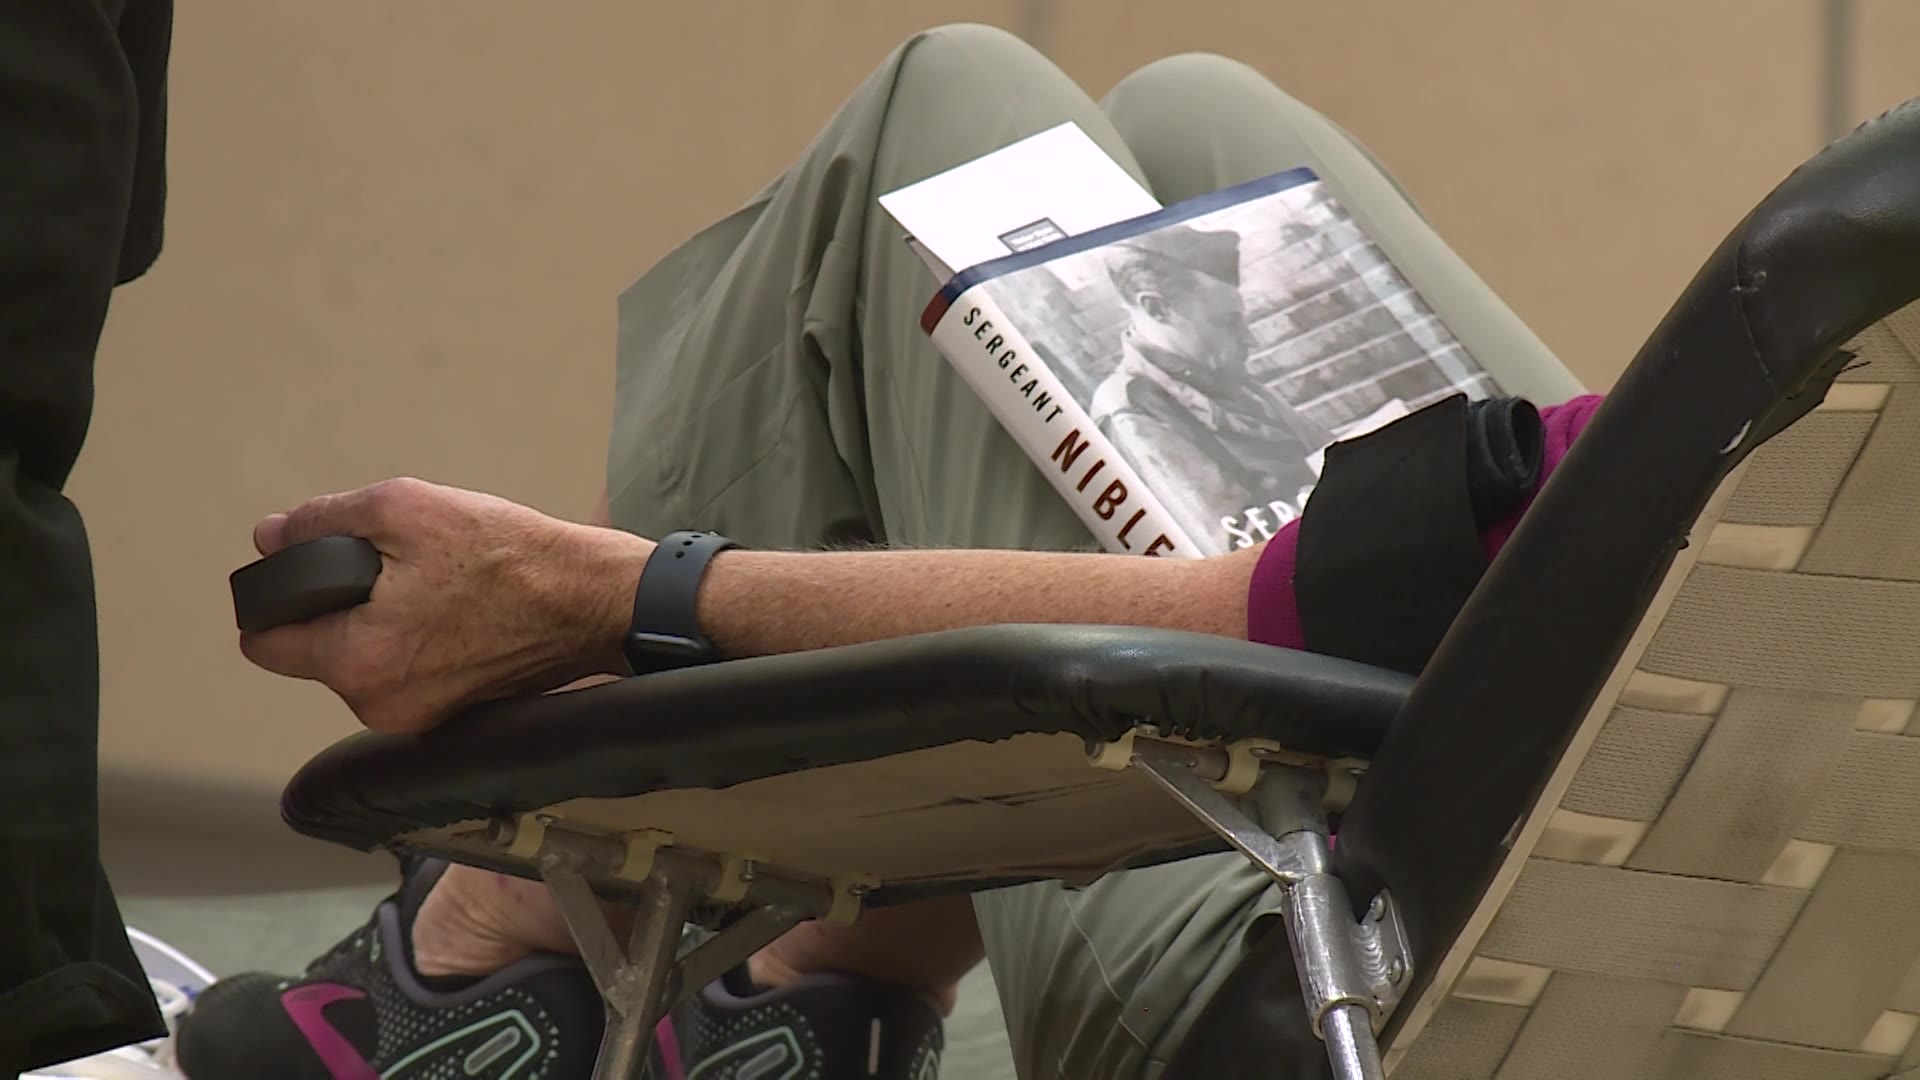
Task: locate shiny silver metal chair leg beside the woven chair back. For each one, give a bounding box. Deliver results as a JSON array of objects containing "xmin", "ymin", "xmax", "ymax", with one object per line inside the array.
[{"xmin": 1133, "ymin": 744, "xmax": 1411, "ymax": 1080}]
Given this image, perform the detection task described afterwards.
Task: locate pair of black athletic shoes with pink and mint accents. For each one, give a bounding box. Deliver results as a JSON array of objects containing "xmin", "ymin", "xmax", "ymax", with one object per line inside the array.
[{"xmin": 173, "ymin": 863, "xmax": 945, "ymax": 1080}]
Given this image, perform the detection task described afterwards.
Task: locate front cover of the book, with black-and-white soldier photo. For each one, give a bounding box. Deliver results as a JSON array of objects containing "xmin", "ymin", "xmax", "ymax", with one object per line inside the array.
[{"xmin": 979, "ymin": 171, "xmax": 1500, "ymax": 553}]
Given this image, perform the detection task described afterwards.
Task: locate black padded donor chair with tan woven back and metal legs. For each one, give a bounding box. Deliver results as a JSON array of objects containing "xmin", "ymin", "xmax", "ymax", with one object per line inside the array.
[{"xmin": 236, "ymin": 102, "xmax": 1920, "ymax": 1080}]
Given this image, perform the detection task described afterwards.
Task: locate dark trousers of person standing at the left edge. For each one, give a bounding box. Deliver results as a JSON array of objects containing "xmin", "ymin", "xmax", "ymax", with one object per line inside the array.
[{"xmin": 0, "ymin": 0, "xmax": 171, "ymax": 1076}]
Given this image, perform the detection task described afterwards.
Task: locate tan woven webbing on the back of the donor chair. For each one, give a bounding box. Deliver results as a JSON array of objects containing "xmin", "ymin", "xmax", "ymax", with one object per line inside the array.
[{"xmin": 1384, "ymin": 304, "xmax": 1920, "ymax": 1080}]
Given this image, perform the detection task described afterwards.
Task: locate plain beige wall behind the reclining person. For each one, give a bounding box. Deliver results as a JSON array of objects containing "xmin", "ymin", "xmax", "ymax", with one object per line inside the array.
[{"xmin": 75, "ymin": 0, "xmax": 1920, "ymax": 878}]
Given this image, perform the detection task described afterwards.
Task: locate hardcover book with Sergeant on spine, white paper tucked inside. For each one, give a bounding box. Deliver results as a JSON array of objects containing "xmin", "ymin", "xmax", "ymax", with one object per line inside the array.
[{"xmin": 881, "ymin": 125, "xmax": 1501, "ymax": 557}]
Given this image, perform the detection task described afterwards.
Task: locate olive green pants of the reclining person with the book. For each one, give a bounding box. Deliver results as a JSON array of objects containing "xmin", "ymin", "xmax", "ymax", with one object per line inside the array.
[{"xmin": 607, "ymin": 27, "xmax": 1578, "ymax": 1080}]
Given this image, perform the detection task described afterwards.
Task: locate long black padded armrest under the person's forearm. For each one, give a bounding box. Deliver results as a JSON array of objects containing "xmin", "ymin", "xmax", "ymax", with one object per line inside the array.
[{"xmin": 282, "ymin": 626, "xmax": 1413, "ymax": 847}]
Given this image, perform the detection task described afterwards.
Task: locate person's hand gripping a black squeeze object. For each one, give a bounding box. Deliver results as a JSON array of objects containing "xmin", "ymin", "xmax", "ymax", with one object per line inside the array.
[{"xmin": 240, "ymin": 480, "xmax": 653, "ymax": 732}]
